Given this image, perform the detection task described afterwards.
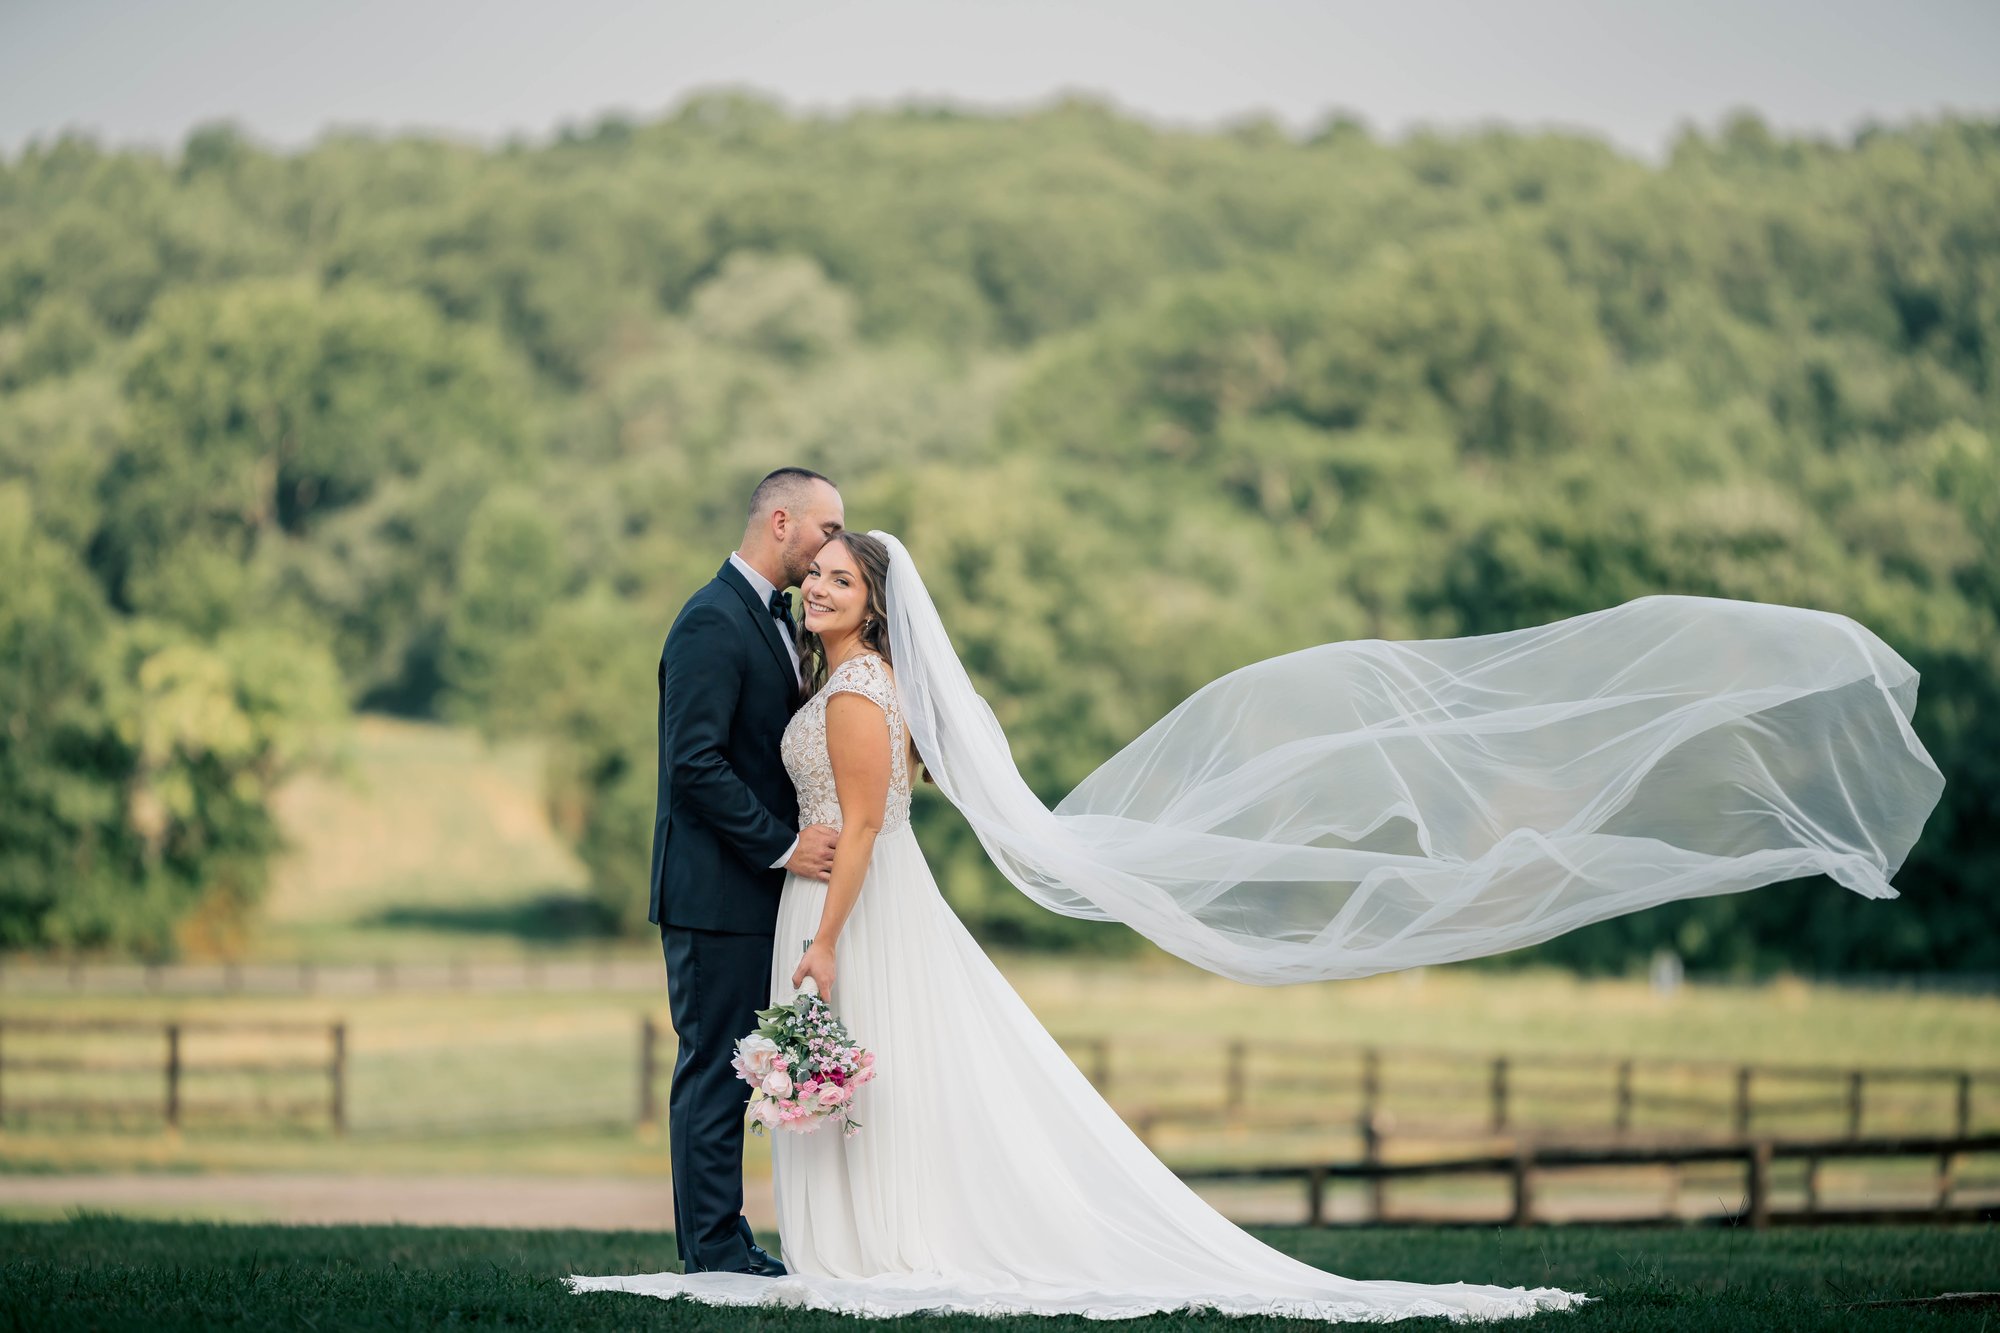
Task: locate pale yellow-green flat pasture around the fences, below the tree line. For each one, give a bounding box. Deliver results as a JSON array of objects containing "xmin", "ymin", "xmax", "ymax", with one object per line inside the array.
[{"xmin": 0, "ymin": 957, "xmax": 2000, "ymax": 1175}]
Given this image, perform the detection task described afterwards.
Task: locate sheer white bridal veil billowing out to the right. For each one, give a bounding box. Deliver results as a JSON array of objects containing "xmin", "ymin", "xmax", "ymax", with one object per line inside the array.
[{"xmin": 872, "ymin": 532, "xmax": 1944, "ymax": 985}]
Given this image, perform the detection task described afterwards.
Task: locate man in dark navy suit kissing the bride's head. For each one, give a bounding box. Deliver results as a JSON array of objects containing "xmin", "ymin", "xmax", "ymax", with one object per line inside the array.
[{"xmin": 648, "ymin": 468, "xmax": 846, "ymax": 1277}]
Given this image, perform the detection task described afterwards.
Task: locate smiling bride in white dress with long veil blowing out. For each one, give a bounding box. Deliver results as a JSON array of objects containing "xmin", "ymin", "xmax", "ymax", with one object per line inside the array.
[{"xmin": 570, "ymin": 532, "xmax": 1942, "ymax": 1321}]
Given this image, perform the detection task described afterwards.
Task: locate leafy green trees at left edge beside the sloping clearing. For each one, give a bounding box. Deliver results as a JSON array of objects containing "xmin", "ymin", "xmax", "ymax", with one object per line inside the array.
[{"xmin": 0, "ymin": 488, "xmax": 342, "ymax": 955}]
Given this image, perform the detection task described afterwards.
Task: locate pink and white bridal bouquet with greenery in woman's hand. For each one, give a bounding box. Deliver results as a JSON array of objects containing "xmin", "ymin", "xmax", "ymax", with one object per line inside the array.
[{"xmin": 730, "ymin": 977, "xmax": 874, "ymax": 1139}]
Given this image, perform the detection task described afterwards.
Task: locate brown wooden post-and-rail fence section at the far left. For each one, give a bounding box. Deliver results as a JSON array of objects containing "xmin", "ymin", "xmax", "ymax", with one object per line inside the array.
[{"xmin": 0, "ymin": 1017, "xmax": 348, "ymax": 1135}]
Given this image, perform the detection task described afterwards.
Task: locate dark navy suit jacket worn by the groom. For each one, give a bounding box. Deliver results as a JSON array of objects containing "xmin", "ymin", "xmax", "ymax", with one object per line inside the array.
[{"xmin": 648, "ymin": 562, "xmax": 798, "ymax": 935}]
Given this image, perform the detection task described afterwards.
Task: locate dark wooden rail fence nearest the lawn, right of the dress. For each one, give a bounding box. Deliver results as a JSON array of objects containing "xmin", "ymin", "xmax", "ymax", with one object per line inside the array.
[{"xmin": 1180, "ymin": 1135, "xmax": 2000, "ymax": 1229}]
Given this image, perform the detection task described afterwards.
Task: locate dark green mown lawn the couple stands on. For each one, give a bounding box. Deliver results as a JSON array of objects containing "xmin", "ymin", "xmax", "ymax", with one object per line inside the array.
[{"xmin": 0, "ymin": 1217, "xmax": 2000, "ymax": 1333}]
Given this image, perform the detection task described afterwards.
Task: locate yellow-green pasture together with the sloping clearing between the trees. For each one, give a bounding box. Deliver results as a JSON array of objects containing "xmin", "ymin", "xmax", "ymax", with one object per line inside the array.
[{"xmin": 0, "ymin": 717, "xmax": 2000, "ymax": 1199}]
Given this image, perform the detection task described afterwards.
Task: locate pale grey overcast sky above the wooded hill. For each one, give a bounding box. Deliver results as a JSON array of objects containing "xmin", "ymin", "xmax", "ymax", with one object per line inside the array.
[{"xmin": 0, "ymin": 0, "xmax": 2000, "ymax": 156}]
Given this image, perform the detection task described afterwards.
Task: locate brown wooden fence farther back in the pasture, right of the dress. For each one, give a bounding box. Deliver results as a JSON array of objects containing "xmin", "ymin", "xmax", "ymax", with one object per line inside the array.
[{"xmin": 1062, "ymin": 1037, "xmax": 2000, "ymax": 1141}]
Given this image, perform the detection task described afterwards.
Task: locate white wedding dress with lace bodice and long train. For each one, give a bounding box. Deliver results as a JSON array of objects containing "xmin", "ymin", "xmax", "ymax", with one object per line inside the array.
[{"xmin": 570, "ymin": 654, "xmax": 1584, "ymax": 1321}]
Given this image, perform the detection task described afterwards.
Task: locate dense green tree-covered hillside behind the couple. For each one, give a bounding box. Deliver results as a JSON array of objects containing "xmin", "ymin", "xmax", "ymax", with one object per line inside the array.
[{"xmin": 0, "ymin": 94, "xmax": 2000, "ymax": 973}]
